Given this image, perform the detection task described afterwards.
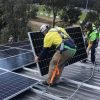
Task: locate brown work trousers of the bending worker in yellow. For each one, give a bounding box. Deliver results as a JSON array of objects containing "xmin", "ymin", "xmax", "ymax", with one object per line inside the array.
[{"xmin": 47, "ymin": 50, "xmax": 76, "ymax": 83}]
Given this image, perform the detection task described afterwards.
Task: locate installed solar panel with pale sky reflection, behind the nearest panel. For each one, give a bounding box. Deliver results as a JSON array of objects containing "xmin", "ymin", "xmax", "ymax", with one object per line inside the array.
[{"xmin": 0, "ymin": 52, "xmax": 33, "ymax": 71}]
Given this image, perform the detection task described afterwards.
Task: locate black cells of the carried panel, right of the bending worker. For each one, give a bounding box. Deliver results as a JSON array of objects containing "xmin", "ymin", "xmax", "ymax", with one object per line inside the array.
[{"xmin": 66, "ymin": 27, "xmax": 87, "ymax": 65}]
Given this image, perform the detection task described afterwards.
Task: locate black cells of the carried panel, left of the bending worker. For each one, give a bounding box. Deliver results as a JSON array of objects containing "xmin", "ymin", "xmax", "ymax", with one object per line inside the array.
[{"xmin": 28, "ymin": 32, "xmax": 55, "ymax": 75}]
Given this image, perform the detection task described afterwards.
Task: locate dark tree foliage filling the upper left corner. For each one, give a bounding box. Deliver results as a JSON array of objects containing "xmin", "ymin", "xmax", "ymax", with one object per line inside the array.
[{"xmin": 0, "ymin": 0, "xmax": 38, "ymax": 42}]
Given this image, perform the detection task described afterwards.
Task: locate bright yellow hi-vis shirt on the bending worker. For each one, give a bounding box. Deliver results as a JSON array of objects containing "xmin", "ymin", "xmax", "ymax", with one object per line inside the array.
[{"xmin": 44, "ymin": 27, "xmax": 69, "ymax": 48}]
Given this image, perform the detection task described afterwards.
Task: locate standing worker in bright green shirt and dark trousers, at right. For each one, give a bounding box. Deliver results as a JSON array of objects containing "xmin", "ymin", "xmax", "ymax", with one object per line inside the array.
[{"xmin": 85, "ymin": 22, "xmax": 98, "ymax": 64}]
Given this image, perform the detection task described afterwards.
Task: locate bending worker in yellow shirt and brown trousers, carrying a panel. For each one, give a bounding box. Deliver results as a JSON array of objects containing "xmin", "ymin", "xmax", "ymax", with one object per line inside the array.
[{"xmin": 35, "ymin": 24, "xmax": 76, "ymax": 86}]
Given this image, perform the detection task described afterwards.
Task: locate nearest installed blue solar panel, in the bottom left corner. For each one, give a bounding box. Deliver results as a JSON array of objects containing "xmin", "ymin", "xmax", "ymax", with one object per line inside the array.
[{"xmin": 0, "ymin": 72, "xmax": 38, "ymax": 100}]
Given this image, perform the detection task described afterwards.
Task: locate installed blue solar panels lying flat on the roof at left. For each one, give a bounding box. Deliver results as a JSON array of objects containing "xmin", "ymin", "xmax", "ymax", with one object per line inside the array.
[{"xmin": 0, "ymin": 41, "xmax": 37, "ymax": 100}]
